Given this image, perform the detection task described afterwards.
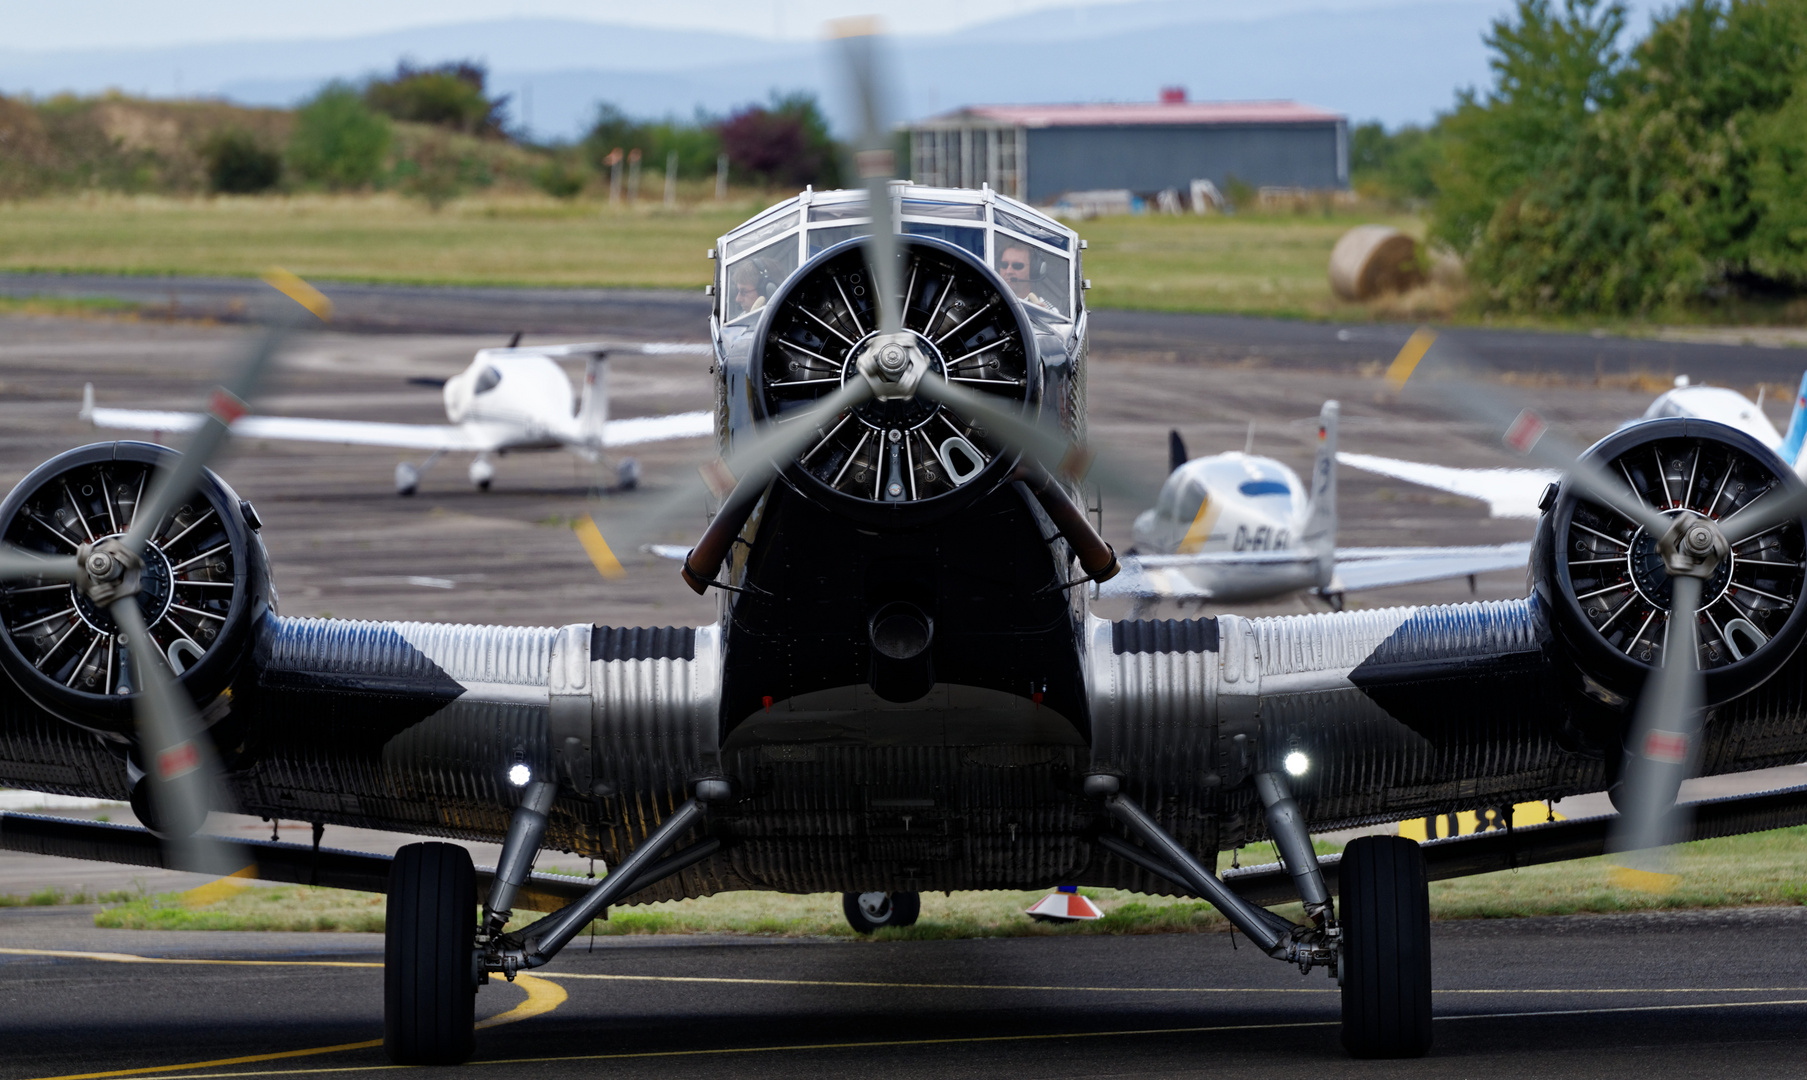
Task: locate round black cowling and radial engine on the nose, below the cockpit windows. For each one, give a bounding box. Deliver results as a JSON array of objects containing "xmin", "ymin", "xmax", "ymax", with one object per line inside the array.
[{"xmin": 752, "ymin": 237, "xmax": 1043, "ymax": 524}]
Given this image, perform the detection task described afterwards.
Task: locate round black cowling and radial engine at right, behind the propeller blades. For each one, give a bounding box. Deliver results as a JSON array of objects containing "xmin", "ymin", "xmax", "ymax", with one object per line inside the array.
[{"xmin": 1532, "ymin": 417, "xmax": 1807, "ymax": 704}]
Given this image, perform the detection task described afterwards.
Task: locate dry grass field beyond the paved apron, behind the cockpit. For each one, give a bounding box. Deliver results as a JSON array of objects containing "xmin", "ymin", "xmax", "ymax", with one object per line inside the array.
[{"xmin": 0, "ymin": 193, "xmax": 1418, "ymax": 318}]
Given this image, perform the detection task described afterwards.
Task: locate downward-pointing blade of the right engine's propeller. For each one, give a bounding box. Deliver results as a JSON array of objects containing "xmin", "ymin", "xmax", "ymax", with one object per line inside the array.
[{"xmin": 1608, "ymin": 574, "xmax": 1702, "ymax": 892}]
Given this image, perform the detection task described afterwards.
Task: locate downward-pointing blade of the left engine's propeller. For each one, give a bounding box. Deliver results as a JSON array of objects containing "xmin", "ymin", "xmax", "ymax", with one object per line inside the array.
[{"xmin": 107, "ymin": 596, "xmax": 244, "ymax": 874}]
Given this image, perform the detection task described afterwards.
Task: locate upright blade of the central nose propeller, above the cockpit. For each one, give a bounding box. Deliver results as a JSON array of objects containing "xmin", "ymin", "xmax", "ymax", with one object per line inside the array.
[{"xmin": 829, "ymin": 18, "xmax": 904, "ymax": 334}]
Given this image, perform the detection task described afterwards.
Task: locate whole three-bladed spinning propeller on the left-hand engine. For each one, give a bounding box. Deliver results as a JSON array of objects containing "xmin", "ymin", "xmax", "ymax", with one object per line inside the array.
[{"xmin": 0, "ymin": 271, "xmax": 331, "ymax": 874}]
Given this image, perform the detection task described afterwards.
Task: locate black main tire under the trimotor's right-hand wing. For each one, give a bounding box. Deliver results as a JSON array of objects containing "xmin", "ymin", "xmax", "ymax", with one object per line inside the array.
[{"xmin": 1337, "ymin": 836, "xmax": 1431, "ymax": 1058}]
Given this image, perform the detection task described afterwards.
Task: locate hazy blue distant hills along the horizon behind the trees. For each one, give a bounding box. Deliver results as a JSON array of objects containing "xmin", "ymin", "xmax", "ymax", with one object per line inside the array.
[{"xmin": 0, "ymin": 0, "xmax": 1503, "ymax": 137}]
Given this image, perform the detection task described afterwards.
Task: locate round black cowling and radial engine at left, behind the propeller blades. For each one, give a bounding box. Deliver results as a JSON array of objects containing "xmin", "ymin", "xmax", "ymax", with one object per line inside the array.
[{"xmin": 0, "ymin": 442, "xmax": 273, "ymax": 735}]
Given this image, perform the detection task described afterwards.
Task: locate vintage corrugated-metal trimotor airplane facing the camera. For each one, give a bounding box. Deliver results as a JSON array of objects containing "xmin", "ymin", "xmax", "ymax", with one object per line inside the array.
[{"xmin": 0, "ymin": 38, "xmax": 1807, "ymax": 1062}]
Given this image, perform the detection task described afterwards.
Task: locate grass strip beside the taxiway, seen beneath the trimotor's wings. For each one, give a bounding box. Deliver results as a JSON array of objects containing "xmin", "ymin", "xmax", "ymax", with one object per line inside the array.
[{"xmin": 81, "ymin": 827, "xmax": 1807, "ymax": 941}]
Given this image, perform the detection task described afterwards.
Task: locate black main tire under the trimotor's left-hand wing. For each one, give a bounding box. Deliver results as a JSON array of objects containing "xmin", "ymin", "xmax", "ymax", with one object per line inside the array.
[{"xmin": 383, "ymin": 843, "xmax": 477, "ymax": 1066}]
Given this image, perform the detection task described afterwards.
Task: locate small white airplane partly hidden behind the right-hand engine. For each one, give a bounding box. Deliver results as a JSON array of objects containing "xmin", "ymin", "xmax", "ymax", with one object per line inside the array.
[{"xmin": 1337, "ymin": 374, "xmax": 1807, "ymax": 518}]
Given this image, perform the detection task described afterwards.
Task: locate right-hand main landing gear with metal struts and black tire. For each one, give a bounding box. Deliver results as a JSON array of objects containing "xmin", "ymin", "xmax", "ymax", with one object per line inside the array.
[{"xmin": 1084, "ymin": 771, "xmax": 1431, "ymax": 1058}]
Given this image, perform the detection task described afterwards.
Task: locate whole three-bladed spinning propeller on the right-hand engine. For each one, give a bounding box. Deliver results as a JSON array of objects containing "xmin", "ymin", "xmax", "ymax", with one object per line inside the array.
[{"xmin": 1388, "ymin": 329, "xmax": 1807, "ymax": 890}]
